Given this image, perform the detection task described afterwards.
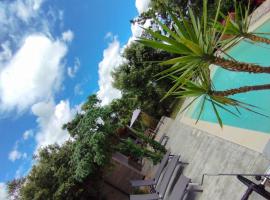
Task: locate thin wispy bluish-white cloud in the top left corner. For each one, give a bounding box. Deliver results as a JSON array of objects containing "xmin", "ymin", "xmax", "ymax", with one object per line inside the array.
[{"xmin": 0, "ymin": 0, "xmax": 48, "ymax": 48}]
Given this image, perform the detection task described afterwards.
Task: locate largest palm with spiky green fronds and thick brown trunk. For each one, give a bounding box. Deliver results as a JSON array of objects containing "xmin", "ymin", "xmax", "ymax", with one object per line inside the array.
[{"xmin": 138, "ymin": 1, "xmax": 270, "ymax": 76}]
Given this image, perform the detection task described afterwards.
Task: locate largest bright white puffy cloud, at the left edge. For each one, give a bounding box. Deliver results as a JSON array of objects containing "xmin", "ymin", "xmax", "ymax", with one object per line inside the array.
[{"xmin": 0, "ymin": 35, "xmax": 67, "ymax": 111}]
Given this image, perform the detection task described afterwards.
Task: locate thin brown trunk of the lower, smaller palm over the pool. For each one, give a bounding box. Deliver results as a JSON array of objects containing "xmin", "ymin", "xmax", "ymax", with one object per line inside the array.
[{"xmin": 211, "ymin": 84, "xmax": 270, "ymax": 97}]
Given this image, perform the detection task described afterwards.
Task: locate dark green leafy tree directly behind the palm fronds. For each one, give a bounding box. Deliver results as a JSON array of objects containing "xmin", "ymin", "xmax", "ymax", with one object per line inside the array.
[{"xmin": 112, "ymin": 43, "xmax": 173, "ymax": 118}]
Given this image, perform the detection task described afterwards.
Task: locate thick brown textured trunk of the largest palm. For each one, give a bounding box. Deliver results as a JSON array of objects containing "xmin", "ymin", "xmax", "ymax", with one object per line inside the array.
[{"xmin": 210, "ymin": 57, "xmax": 270, "ymax": 74}]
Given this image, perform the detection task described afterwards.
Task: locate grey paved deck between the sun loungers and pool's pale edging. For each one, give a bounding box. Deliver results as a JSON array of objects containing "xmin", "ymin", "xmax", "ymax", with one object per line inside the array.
[{"xmin": 156, "ymin": 114, "xmax": 270, "ymax": 200}]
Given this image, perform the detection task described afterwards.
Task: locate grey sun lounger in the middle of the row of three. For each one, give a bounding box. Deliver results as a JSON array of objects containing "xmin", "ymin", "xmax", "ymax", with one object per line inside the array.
[{"xmin": 130, "ymin": 156, "xmax": 180, "ymax": 200}]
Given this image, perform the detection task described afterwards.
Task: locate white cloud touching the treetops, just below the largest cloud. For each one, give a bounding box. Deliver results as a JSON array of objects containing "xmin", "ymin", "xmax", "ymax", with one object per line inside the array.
[{"xmin": 32, "ymin": 101, "xmax": 76, "ymax": 149}]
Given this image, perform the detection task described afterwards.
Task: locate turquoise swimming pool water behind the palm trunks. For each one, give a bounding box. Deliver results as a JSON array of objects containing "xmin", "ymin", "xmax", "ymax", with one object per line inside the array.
[{"xmin": 191, "ymin": 20, "xmax": 270, "ymax": 134}]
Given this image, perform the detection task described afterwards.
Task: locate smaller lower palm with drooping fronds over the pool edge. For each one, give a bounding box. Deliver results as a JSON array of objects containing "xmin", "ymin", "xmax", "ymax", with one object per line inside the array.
[{"xmin": 172, "ymin": 73, "xmax": 270, "ymax": 127}]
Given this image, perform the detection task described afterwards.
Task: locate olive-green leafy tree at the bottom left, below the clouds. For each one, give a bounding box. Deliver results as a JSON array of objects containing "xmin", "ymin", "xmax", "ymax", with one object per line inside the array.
[{"xmin": 17, "ymin": 141, "xmax": 104, "ymax": 200}]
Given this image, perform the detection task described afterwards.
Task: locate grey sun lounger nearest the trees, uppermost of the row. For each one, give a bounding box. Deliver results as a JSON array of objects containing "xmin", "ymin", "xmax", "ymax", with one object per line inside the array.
[{"xmin": 130, "ymin": 150, "xmax": 171, "ymax": 187}]
